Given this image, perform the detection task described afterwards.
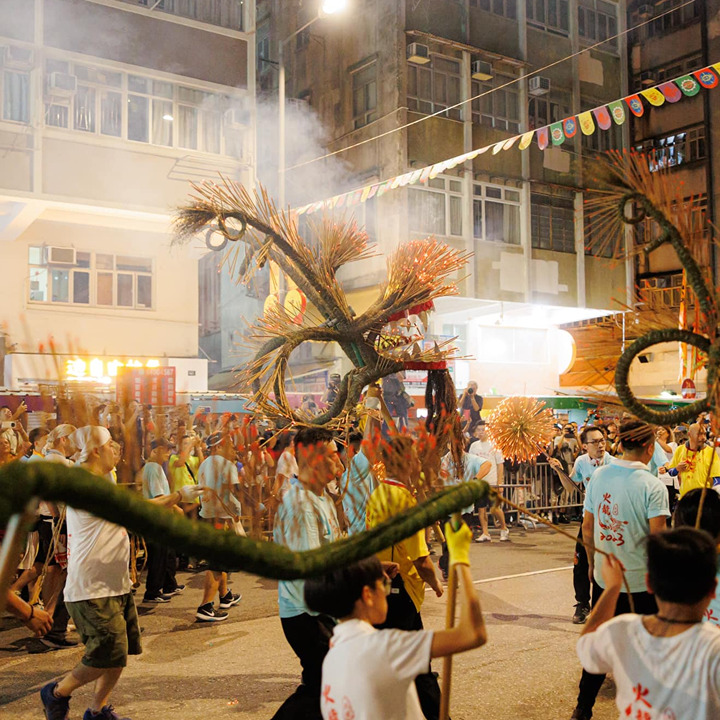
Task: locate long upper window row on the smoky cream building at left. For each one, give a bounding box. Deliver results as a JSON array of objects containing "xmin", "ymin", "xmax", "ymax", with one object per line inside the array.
[{"xmin": 45, "ymin": 60, "xmax": 242, "ymax": 155}]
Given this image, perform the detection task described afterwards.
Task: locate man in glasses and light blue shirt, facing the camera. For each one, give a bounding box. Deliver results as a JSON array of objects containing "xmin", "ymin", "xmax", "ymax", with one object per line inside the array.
[{"xmin": 548, "ymin": 425, "xmax": 615, "ymax": 625}]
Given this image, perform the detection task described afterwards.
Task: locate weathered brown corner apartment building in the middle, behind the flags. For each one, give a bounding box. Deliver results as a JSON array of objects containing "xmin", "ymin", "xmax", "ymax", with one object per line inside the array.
[{"xmin": 257, "ymin": 0, "xmax": 632, "ymax": 393}]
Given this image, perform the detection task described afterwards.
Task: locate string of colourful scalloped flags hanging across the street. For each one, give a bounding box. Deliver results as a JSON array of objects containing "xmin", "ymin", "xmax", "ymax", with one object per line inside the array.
[{"xmin": 295, "ymin": 62, "xmax": 720, "ymax": 215}]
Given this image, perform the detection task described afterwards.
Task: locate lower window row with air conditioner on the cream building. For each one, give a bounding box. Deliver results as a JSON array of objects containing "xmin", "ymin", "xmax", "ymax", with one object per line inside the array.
[{"xmin": 28, "ymin": 246, "xmax": 153, "ymax": 310}]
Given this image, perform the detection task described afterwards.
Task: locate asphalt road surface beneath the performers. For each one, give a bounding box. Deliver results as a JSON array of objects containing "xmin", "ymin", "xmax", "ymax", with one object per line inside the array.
[{"xmin": 0, "ymin": 526, "xmax": 617, "ymax": 720}]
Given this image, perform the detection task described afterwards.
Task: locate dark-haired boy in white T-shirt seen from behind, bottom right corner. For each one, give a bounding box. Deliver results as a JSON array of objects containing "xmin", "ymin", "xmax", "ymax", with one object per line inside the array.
[{"xmin": 573, "ymin": 527, "xmax": 720, "ymax": 720}]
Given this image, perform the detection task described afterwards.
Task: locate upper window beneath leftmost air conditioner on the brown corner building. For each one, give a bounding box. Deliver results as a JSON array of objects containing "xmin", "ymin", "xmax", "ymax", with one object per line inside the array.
[{"xmin": 408, "ymin": 55, "xmax": 462, "ymax": 120}]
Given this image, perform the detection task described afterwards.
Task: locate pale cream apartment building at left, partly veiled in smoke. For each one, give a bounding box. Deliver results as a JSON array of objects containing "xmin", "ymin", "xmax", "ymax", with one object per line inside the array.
[{"xmin": 0, "ymin": 0, "xmax": 255, "ymax": 391}]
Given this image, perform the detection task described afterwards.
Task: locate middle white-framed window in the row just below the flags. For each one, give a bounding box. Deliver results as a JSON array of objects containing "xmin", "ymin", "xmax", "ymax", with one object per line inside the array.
[{"xmin": 473, "ymin": 183, "xmax": 520, "ymax": 245}]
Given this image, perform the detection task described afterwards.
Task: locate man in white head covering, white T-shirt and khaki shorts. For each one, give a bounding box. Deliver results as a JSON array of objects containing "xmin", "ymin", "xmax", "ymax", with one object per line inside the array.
[{"xmin": 40, "ymin": 425, "xmax": 202, "ymax": 720}]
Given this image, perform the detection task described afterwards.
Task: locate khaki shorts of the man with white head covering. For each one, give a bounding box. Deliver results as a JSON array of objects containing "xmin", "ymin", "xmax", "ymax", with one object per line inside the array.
[{"xmin": 65, "ymin": 593, "xmax": 142, "ymax": 668}]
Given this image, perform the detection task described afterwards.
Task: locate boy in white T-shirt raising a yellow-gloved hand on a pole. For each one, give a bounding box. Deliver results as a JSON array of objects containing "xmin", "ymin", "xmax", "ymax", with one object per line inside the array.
[{"xmin": 305, "ymin": 523, "xmax": 487, "ymax": 720}]
